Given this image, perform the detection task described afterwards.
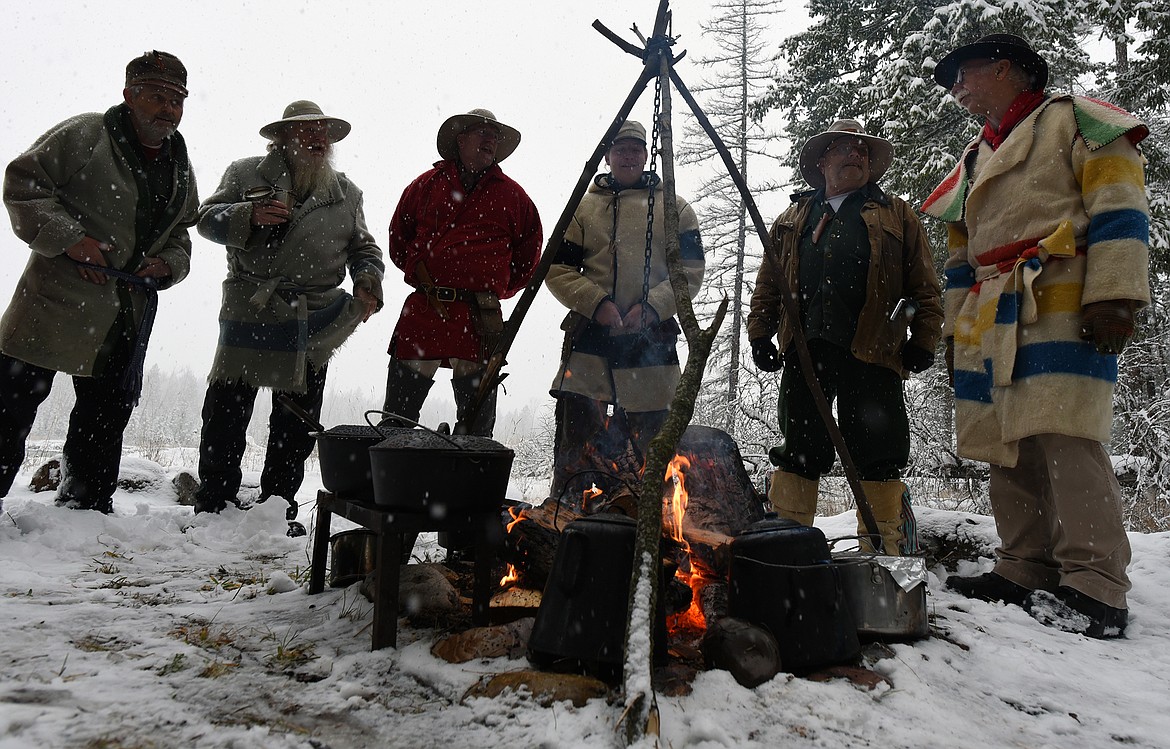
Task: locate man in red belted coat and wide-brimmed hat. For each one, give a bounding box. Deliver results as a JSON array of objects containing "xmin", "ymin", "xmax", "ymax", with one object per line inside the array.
[{"xmin": 383, "ymin": 109, "xmax": 543, "ymax": 437}]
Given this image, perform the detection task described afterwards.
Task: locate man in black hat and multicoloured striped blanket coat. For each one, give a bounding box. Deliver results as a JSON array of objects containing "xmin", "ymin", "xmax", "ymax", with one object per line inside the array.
[{"xmin": 923, "ymin": 34, "xmax": 1150, "ymax": 638}]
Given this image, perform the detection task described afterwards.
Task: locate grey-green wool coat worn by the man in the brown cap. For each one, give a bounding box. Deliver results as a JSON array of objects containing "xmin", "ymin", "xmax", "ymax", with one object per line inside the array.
[{"xmin": 0, "ymin": 104, "xmax": 199, "ymax": 377}]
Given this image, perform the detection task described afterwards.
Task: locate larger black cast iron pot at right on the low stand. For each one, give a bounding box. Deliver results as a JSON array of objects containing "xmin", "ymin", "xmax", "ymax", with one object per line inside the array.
[{"xmin": 370, "ymin": 430, "xmax": 516, "ymax": 518}]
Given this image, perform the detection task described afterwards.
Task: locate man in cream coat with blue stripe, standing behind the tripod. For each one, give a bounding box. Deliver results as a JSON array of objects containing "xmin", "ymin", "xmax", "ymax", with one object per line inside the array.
[{"xmin": 545, "ymin": 121, "xmax": 704, "ymax": 502}]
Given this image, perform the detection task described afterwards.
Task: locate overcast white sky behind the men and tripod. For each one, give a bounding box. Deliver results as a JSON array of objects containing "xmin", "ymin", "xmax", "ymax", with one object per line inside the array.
[{"xmin": 0, "ymin": 0, "xmax": 805, "ymax": 421}]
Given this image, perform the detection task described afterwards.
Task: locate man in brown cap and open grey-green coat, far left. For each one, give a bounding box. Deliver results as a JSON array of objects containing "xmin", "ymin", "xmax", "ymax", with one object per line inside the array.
[{"xmin": 0, "ymin": 50, "xmax": 199, "ymax": 513}]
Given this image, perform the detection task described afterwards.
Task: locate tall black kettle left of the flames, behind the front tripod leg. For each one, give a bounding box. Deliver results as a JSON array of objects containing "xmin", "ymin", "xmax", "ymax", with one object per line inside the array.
[{"xmin": 528, "ymin": 513, "xmax": 666, "ymax": 680}]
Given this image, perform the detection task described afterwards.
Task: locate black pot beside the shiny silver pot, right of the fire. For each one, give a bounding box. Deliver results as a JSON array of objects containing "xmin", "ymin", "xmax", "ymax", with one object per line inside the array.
[{"xmin": 728, "ymin": 516, "xmax": 861, "ymax": 674}]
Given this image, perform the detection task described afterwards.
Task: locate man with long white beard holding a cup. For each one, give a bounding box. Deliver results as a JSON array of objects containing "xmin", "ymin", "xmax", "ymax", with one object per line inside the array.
[{"xmin": 195, "ymin": 101, "xmax": 385, "ymax": 535}]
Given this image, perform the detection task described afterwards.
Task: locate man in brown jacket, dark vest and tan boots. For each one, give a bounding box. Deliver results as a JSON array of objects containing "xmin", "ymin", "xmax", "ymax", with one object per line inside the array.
[{"xmin": 748, "ymin": 119, "xmax": 942, "ymax": 555}]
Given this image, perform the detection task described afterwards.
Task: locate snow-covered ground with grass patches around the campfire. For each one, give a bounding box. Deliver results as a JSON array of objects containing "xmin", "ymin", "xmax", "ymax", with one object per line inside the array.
[{"xmin": 0, "ymin": 461, "xmax": 1170, "ymax": 749}]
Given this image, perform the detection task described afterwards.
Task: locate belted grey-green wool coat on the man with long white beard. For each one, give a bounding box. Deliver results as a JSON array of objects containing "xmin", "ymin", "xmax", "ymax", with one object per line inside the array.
[{"xmin": 199, "ymin": 152, "xmax": 385, "ymax": 392}]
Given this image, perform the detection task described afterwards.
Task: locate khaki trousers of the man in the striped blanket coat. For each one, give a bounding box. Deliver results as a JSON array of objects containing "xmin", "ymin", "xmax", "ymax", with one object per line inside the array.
[{"xmin": 990, "ymin": 434, "xmax": 1130, "ymax": 609}]
